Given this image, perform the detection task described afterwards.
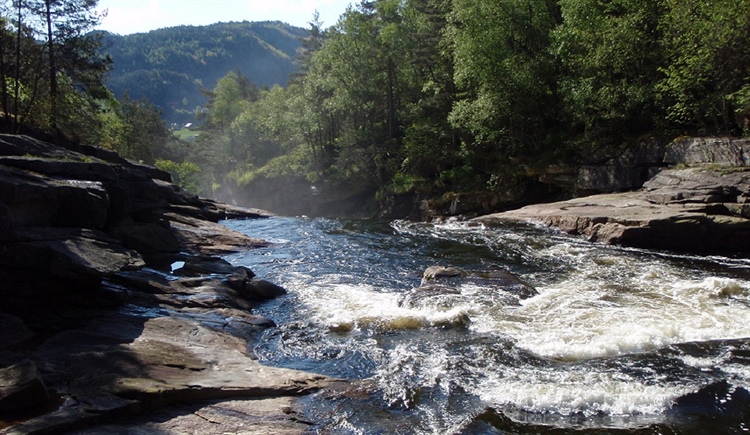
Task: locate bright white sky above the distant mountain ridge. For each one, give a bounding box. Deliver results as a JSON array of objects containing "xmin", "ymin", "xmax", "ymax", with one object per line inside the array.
[{"xmin": 97, "ymin": 0, "xmax": 358, "ymax": 35}]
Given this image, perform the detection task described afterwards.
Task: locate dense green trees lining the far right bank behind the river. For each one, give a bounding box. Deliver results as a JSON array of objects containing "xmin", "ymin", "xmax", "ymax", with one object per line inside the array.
[{"xmin": 188, "ymin": 0, "xmax": 750, "ymax": 215}]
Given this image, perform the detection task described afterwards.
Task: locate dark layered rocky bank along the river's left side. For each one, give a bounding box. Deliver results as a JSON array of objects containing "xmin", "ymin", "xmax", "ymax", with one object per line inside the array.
[{"xmin": 0, "ymin": 135, "xmax": 332, "ymax": 433}]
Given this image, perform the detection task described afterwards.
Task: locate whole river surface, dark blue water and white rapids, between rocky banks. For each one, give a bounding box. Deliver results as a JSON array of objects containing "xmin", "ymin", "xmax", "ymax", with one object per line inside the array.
[{"xmin": 225, "ymin": 217, "xmax": 750, "ymax": 434}]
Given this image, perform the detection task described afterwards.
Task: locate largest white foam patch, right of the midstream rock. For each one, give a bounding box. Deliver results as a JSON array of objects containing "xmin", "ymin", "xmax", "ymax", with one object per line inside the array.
[{"xmin": 475, "ymin": 267, "xmax": 750, "ymax": 360}]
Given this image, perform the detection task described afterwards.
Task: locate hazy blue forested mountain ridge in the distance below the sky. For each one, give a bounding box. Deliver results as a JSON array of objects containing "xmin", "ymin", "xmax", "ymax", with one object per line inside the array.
[{"xmin": 102, "ymin": 21, "xmax": 307, "ymax": 123}]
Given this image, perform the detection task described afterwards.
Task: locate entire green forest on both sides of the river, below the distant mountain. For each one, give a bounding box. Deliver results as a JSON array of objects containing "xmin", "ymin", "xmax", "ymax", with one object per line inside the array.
[{"xmin": 0, "ymin": 0, "xmax": 750, "ymax": 215}]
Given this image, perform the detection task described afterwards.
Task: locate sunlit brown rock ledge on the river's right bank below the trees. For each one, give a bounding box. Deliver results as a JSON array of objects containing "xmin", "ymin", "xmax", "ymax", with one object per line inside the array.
[{"xmin": 475, "ymin": 138, "xmax": 750, "ymax": 255}]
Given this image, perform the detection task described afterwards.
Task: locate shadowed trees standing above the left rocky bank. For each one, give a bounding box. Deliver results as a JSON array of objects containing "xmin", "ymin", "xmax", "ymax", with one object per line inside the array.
[{"xmin": 0, "ymin": 0, "xmax": 187, "ymax": 166}]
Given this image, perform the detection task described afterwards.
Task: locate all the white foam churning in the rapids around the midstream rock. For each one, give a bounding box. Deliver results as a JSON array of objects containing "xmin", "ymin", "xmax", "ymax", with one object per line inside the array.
[{"xmin": 276, "ymin": 240, "xmax": 750, "ymax": 415}]
